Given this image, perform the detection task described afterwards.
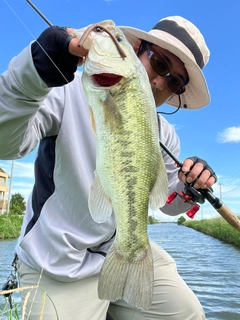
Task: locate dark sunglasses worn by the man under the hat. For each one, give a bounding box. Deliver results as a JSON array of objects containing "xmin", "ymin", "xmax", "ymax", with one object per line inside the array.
[{"xmin": 147, "ymin": 45, "xmax": 185, "ymax": 95}]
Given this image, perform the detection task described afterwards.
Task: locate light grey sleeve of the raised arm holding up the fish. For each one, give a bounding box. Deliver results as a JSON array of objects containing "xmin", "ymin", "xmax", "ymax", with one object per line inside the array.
[{"xmin": 0, "ymin": 45, "xmax": 63, "ymax": 160}]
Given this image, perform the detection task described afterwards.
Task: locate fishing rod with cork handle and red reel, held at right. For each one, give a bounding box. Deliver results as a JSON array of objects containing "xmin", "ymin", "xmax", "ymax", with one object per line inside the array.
[{"xmin": 159, "ymin": 141, "xmax": 240, "ymax": 232}]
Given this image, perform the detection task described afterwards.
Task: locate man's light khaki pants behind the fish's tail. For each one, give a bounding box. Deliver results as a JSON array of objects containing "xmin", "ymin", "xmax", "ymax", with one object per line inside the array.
[{"xmin": 18, "ymin": 242, "xmax": 205, "ymax": 320}]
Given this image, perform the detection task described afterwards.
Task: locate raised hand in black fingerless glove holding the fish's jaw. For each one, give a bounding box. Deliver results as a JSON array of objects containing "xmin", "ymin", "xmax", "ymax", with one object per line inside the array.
[{"xmin": 31, "ymin": 26, "xmax": 87, "ymax": 87}]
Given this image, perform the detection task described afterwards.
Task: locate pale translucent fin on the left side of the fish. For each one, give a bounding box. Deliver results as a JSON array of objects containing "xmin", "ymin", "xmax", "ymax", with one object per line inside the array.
[{"xmin": 88, "ymin": 172, "xmax": 112, "ymax": 223}]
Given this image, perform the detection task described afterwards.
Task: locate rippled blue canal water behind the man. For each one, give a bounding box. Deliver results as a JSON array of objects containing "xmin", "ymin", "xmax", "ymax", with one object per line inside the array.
[{"xmin": 0, "ymin": 223, "xmax": 240, "ymax": 320}]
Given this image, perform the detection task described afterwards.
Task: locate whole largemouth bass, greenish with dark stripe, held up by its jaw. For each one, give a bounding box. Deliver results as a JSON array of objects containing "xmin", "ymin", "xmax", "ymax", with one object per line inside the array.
[{"xmin": 74, "ymin": 20, "xmax": 168, "ymax": 309}]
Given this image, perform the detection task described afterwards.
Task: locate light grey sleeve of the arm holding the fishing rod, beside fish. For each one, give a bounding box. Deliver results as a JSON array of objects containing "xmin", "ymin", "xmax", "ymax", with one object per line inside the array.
[{"xmin": 158, "ymin": 115, "xmax": 191, "ymax": 216}]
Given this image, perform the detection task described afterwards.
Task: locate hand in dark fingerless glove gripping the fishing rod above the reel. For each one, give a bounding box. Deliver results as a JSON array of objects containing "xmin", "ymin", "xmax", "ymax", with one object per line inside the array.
[{"xmin": 179, "ymin": 157, "xmax": 217, "ymax": 189}]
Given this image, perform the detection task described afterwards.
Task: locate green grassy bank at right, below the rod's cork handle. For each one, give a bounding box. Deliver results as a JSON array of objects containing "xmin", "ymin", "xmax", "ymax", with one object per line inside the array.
[{"xmin": 183, "ymin": 217, "xmax": 240, "ymax": 248}]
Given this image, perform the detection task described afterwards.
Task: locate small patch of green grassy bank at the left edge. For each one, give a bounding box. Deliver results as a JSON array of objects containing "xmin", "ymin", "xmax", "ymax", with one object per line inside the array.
[{"xmin": 0, "ymin": 214, "xmax": 23, "ymax": 239}]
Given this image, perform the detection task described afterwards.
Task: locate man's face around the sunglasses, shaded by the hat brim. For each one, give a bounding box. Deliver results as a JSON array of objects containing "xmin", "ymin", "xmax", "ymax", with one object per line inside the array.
[{"xmin": 139, "ymin": 46, "xmax": 188, "ymax": 107}]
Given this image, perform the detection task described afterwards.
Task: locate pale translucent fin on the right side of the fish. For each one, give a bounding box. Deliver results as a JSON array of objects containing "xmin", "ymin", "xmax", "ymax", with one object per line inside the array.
[{"xmin": 149, "ymin": 157, "xmax": 168, "ymax": 210}]
